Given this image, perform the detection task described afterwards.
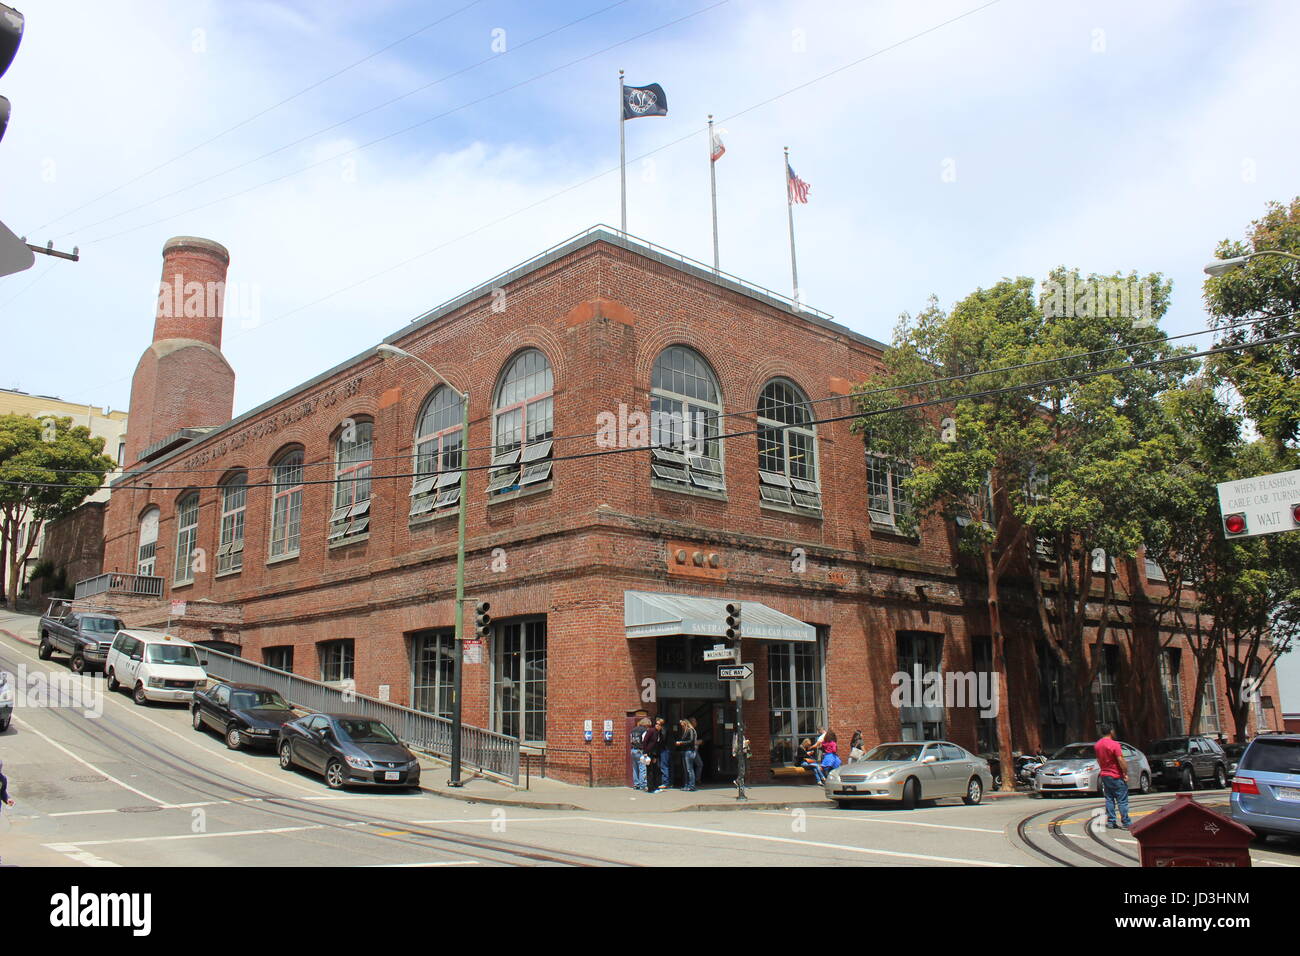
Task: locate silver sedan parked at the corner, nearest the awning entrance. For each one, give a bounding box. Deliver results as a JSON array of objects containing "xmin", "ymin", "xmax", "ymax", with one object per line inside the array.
[{"xmin": 824, "ymin": 740, "xmax": 993, "ymax": 809}]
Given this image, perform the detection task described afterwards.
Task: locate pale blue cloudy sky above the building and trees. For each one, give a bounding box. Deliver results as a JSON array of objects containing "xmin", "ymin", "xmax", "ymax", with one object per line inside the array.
[{"xmin": 0, "ymin": 0, "xmax": 1300, "ymax": 706}]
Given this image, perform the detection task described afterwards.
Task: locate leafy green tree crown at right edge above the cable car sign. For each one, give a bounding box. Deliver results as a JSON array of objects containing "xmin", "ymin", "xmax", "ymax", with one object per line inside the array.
[{"xmin": 1205, "ymin": 198, "xmax": 1300, "ymax": 450}]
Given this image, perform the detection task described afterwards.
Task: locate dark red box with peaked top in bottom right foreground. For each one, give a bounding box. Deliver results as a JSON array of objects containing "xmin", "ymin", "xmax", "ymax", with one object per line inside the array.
[{"xmin": 1130, "ymin": 793, "xmax": 1255, "ymax": 866}]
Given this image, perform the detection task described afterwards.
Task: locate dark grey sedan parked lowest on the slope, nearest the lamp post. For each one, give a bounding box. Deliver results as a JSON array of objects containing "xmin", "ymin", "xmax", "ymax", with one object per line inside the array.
[{"xmin": 280, "ymin": 714, "xmax": 420, "ymax": 790}]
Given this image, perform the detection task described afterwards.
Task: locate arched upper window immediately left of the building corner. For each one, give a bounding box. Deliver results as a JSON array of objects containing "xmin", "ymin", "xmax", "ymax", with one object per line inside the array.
[{"xmin": 488, "ymin": 349, "xmax": 555, "ymax": 494}]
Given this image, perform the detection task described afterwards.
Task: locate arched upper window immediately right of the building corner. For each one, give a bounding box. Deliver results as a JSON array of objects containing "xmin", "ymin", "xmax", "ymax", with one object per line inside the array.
[{"xmin": 650, "ymin": 345, "xmax": 727, "ymax": 492}]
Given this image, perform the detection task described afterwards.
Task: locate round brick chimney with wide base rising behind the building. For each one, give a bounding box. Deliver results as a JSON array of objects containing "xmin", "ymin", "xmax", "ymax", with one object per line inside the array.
[{"xmin": 126, "ymin": 235, "xmax": 235, "ymax": 467}]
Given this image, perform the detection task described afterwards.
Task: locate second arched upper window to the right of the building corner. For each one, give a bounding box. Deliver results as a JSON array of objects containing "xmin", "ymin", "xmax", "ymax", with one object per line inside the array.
[{"xmin": 758, "ymin": 378, "xmax": 822, "ymax": 511}]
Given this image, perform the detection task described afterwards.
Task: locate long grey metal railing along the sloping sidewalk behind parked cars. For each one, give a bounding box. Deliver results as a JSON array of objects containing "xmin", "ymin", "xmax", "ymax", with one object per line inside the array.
[{"xmin": 200, "ymin": 648, "xmax": 519, "ymax": 784}]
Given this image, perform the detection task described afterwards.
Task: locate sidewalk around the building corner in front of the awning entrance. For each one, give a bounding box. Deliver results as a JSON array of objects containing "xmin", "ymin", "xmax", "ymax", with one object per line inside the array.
[{"xmin": 421, "ymin": 760, "xmax": 1026, "ymax": 813}]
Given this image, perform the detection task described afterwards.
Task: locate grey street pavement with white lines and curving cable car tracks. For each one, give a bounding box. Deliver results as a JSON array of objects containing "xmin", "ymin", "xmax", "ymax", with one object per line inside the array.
[{"xmin": 0, "ymin": 613, "xmax": 1300, "ymax": 868}]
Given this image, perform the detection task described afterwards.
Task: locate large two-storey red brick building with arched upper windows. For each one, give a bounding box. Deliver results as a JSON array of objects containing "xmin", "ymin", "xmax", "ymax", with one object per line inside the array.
[{"xmin": 98, "ymin": 229, "xmax": 1281, "ymax": 782}]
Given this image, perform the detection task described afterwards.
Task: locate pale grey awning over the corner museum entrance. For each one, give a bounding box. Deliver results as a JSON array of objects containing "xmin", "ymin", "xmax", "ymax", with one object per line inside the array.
[{"xmin": 623, "ymin": 591, "xmax": 816, "ymax": 641}]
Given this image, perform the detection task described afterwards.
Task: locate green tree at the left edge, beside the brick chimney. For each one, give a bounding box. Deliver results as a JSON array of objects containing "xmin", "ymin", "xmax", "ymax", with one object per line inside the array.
[{"xmin": 0, "ymin": 415, "xmax": 113, "ymax": 610}]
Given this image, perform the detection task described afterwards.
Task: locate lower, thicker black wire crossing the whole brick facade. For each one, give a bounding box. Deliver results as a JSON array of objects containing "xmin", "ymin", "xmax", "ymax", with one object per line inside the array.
[{"xmin": 0, "ymin": 332, "xmax": 1300, "ymax": 492}]
